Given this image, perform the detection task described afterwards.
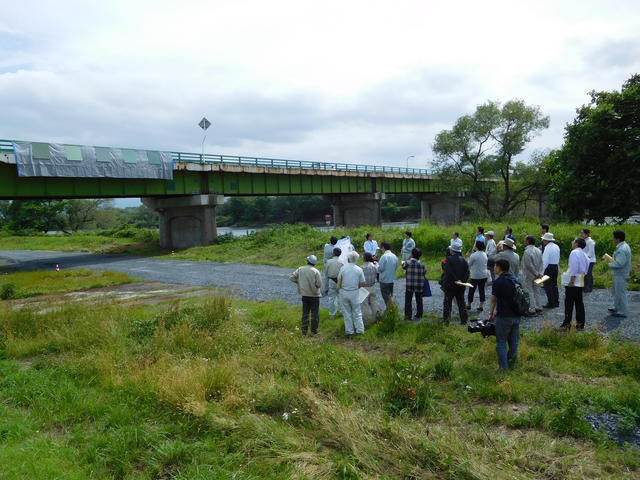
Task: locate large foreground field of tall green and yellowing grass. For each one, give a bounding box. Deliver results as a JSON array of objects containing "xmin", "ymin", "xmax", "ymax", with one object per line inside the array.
[{"xmin": 0, "ymin": 276, "xmax": 640, "ymax": 480}]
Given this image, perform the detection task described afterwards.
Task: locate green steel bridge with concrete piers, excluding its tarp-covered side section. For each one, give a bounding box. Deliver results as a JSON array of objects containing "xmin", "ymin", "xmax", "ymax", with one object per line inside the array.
[{"xmin": 0, "ymin": 140, "xmax": 464, "ymax": 248}]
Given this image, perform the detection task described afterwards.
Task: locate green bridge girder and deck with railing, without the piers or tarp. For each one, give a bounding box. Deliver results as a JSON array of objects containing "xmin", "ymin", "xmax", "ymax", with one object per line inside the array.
[{"xmin": 0, "ymin": 140, "xmax": 456, "ymax": 199}]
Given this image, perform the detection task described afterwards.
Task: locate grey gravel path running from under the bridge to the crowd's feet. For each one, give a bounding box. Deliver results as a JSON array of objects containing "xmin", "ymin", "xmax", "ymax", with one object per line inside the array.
[{"xmin": 0, "ymin": 250, "xmax": 640, "ymax": 340}]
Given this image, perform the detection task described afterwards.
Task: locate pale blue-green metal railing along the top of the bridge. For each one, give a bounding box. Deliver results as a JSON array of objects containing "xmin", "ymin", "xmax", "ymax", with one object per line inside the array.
[{"xmin": 0, "ymin": 140, "xmax": 428, "ymax": 175}]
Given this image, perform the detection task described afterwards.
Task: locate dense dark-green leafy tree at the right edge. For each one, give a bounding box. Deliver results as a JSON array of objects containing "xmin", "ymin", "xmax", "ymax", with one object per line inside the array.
[{"xmin": 551, "ymin": 74, "xmax": 640, "ymax": 222}]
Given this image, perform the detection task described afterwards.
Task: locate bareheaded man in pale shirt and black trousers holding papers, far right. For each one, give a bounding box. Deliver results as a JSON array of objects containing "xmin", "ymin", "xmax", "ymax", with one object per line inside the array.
[{"xmin": 560, "ymin": 238, "xmax": 589, "ymax": 331}]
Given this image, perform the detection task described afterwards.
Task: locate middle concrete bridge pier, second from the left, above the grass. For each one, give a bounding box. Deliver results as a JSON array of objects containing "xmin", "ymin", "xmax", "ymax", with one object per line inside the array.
[{"xmin": 325, "ymin": 192, "xmax": 385, "ymax": 227}]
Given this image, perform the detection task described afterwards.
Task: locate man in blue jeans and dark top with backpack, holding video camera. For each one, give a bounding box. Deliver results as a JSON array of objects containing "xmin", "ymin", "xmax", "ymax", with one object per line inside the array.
[{"xmin": 489, "ymin": 259, "xmax": 520, "ymax": 370}]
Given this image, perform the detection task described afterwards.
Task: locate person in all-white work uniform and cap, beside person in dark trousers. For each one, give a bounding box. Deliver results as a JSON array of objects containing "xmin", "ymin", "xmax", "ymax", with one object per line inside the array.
[{"xmin": 338, "ymin": 252, "xmax": 365, "ymax": 337}]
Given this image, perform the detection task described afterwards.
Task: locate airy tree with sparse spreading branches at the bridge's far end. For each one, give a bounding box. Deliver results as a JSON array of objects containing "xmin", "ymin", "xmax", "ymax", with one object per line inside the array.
[{"xmin": 433, "ymin": 100, "xmax": 549, "ymax": 216}]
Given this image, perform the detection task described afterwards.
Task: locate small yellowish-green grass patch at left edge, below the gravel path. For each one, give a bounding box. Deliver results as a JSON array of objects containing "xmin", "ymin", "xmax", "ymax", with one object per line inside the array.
[{"xmin": 0, "ymin": 269, "xmax": 134, "ymax": 299}]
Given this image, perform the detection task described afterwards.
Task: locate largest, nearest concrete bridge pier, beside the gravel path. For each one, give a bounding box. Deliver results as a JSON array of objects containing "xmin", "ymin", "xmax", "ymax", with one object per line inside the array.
[{"xmin": 142, "ymin": 195, "xmax": 224, "ymax": 248}]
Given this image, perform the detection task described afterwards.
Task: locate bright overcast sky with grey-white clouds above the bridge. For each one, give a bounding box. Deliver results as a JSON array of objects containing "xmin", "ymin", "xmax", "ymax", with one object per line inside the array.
[{"xmin": 0, "ymin": 0, "xmax": 640, "ymax": 173}]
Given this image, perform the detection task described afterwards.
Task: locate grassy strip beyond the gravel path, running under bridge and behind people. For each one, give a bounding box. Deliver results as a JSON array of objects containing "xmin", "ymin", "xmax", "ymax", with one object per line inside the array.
[{"xmin": 0, "ymin": 222, "xmax": 640, "ymax": 290}]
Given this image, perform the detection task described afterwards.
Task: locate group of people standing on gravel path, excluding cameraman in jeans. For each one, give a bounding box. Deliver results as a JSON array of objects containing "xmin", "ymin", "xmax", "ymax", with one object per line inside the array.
[{"xmin": 291, "ymin": 224, "xmax": 631, "ymax": 348}]
